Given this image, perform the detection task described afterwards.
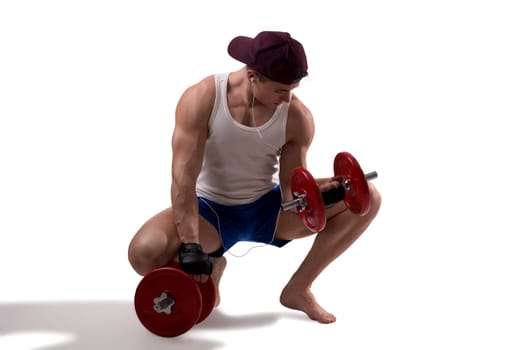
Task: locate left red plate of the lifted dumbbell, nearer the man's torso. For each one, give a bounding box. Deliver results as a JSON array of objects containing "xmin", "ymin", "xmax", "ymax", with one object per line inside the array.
[{"xmin": 290, "ymin": 167, "xmax": 326, "ymax": 232}]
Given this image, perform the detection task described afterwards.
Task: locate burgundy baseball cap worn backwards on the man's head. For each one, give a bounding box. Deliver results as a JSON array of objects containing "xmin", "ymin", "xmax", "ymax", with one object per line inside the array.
[{"xmin": 228, "ymin": 31, "xmax": 308, "ymax": 84}]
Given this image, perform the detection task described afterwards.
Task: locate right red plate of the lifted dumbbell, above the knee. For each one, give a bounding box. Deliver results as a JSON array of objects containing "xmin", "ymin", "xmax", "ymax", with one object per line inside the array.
[{"xmin": 334, "ymin": 152, "xmax": 370, "ymax": 216}]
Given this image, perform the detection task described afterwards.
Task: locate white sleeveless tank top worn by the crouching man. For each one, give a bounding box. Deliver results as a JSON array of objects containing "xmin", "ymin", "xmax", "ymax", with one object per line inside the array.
[{"xmin": 196, "ymin": 73, "xmax": 289, "ymax": 205}]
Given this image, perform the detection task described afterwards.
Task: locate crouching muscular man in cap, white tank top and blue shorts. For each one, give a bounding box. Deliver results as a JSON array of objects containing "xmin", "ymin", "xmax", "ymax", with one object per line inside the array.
[{"xmin": 129, "ymin": 31, "xmax": 381, "ymax": 323}]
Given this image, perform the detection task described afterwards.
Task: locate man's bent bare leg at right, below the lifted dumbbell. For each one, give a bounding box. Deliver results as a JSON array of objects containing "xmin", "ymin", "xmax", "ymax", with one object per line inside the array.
[{"xmin": 276, "ymin": 184, "xmax": 381, "ymax": 323}]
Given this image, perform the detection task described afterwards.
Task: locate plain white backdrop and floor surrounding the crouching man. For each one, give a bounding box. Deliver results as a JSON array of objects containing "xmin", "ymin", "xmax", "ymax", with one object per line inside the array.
[{"xmin": 0, "ymin": 0, "xmax": 525, "ymax": 350}]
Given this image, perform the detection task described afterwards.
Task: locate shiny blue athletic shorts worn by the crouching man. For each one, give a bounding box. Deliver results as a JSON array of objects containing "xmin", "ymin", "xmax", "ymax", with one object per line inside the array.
[{"xmin": 198, "ymin": 186, "xmax": 289, "ymax": 256}]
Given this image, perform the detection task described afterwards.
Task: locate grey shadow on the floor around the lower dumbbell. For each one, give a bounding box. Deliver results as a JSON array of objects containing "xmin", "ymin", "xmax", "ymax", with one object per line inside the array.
[{"xmin": 0, "ymin": 301, "xmax": 305, "ymax": 350}]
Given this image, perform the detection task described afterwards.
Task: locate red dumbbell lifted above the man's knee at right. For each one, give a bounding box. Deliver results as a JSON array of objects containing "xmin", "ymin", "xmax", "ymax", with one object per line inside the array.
[{"xmin": 281, "ymin": 152, "xmax": 377, "ymax": 232}]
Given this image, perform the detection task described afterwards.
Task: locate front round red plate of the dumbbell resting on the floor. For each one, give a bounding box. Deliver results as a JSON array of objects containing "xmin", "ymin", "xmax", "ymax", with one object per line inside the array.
[{"xmin": 135, "ymin": 267, "xmax": 202, "ymax": 337}]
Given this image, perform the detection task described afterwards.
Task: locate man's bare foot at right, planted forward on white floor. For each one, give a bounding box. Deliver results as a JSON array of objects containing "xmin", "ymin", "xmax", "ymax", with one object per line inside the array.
[{"xmin": 280, "ymin": 283, "xmax": 335, "ymax": 323}]
